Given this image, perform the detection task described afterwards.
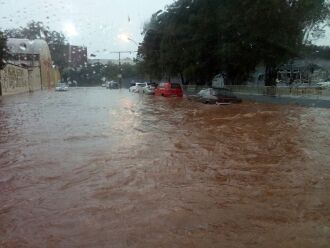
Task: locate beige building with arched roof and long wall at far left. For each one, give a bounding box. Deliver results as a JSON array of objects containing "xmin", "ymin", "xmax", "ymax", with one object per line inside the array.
[{"xmin": 0, "ymin": 38, "xmax": 60, "ymax": 95}]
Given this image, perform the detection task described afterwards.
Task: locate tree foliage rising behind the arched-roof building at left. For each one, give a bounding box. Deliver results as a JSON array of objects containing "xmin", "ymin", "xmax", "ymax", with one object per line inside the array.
[{"xmin": 5, "ymin": 21, "xmax": 68, "ymax": 71}]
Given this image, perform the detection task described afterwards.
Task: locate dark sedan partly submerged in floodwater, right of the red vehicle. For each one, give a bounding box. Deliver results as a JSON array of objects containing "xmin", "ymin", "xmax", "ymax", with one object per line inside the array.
[{"xmin": 188, "ymin": 88, "xmax": 242, "ymax": 104}]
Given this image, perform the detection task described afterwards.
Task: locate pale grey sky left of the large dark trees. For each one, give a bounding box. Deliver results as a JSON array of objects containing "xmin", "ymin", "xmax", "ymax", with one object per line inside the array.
[{"xmin": 0, "ymin": 0, "xmax": 173, "ymax": 58}]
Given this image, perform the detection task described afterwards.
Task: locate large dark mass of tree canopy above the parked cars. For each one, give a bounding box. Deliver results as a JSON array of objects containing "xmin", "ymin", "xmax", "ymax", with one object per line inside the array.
[{"xmin": 138, "ymin": 0, "xmax": 329, "ymax": 84}]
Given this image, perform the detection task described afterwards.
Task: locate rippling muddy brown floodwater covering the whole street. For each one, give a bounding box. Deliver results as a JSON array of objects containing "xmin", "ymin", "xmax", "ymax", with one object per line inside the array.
[{"xmin": 0, "ymin": 88, "xmax": 330, "ymax": 248}]
